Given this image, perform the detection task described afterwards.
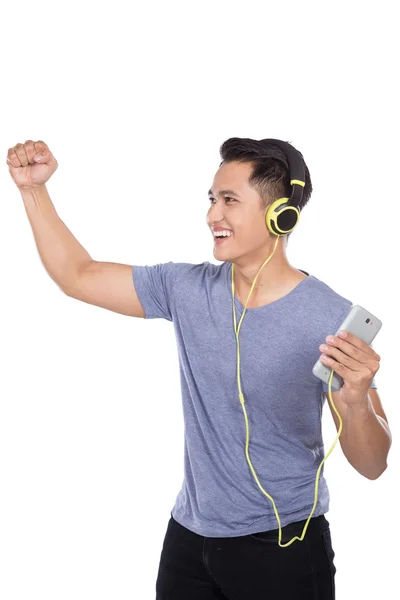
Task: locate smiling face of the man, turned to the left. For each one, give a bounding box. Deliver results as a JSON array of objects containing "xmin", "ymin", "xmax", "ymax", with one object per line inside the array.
[{"xmin": 207, "ymin": 162, "xmax": 271, "ymax": 262}]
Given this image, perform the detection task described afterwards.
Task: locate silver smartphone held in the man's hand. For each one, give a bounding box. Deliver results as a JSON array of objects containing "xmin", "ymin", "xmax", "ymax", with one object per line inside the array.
[{"xmin": 312, "ymin": 304, "xmax": 382, "ymax": 388}]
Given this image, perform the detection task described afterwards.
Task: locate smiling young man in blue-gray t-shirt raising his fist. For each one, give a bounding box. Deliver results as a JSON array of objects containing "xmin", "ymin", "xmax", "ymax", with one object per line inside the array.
[{"xmin": 8, "ymin": 138, "xmax": 391, "ymax": 600}]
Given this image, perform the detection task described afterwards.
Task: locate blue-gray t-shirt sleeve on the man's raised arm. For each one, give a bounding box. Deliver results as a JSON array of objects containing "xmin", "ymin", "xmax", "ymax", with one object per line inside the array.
[{"xmin": 132, "ymin": 261, "xmax": 181, "ymax": 321}]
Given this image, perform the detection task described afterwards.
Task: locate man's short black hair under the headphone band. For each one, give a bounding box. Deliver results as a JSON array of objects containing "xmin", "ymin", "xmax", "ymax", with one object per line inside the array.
[{"xmin": 219, "ymin": 137, "xmax": 312, "ymax": 237}]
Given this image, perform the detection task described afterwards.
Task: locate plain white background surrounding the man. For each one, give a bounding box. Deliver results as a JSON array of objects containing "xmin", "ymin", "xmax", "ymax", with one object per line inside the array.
[{"xmin": 0, "ymin": 0, "xmax": 400, "ymax": 600}]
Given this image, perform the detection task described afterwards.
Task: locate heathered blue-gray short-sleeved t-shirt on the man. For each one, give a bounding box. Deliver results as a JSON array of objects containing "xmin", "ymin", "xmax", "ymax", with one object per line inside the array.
[{"xmin": 132, "ymin": 261, "xmax": 376, "ymax": 537}]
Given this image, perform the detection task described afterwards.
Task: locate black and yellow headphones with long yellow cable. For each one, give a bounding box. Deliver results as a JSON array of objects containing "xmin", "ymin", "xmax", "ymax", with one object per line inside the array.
[{"xmin": 231, "ymin": 139, "xmax": 343, "ymax": 548}]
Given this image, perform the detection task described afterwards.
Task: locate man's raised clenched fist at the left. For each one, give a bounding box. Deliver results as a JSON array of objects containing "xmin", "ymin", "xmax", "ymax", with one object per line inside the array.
[{"xmin": 7, "ymin": 140, "xmax": 58, "ymax": 189}]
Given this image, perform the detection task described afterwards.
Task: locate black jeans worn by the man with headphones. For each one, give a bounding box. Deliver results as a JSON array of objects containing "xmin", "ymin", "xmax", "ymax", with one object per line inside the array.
[{"xmin": 156, "ymin": 514, "xmax": 336, "ymax": 600}]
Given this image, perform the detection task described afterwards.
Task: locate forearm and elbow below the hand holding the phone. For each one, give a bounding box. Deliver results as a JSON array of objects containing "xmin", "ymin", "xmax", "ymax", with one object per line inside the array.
[{"xmin": 340, "ymin": 394, "xmax": 392, "ymax": 479}]
